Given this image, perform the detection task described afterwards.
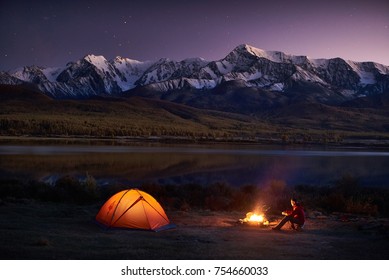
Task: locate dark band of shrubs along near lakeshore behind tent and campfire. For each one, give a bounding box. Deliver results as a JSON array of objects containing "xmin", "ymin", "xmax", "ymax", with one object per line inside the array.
[{"xmin": 0, "ymin": 174, "xmax": 389, "ymax": 217}]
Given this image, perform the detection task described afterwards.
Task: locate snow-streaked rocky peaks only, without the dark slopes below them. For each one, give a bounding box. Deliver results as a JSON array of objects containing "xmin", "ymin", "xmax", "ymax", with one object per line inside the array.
[{"xmin": 0, "ymin": 45, "xmax": 389, "ymax": 99}]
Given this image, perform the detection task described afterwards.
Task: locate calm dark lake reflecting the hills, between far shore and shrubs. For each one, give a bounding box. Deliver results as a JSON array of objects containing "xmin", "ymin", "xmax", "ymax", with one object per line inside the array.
[{"xmin": 0, "ymin": 144, "xmax": 389, "ymax": 187}]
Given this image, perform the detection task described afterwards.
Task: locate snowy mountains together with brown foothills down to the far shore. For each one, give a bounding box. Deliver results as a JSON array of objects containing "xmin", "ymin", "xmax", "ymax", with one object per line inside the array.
[{"xmin": 0, "ymin": 45, "xmax": 389, "ymax": 139}]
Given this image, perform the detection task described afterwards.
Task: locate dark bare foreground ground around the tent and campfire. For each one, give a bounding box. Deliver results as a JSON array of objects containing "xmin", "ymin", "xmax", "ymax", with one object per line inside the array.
[{"xmin": 0, "ymin": 200, "xmax": 389, "ymax": 260}]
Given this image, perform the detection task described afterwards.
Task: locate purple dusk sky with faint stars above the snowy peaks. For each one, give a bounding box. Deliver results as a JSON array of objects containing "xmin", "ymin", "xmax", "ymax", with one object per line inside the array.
[{"xmin": 0, "ymin": 0, "xmax": 389, "ymax": 71}]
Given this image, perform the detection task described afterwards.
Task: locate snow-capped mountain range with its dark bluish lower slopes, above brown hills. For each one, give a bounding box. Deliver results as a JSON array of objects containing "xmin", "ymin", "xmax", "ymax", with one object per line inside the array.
[{"xmin": 0, "ymin": 45, "xmax": 389, "ymax": 121}]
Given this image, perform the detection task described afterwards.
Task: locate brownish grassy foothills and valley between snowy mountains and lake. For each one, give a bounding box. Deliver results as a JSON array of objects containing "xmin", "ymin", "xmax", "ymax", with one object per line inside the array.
[{"xmin": 0, "ymin": 85, "xmax": 389, "ymax": 145}]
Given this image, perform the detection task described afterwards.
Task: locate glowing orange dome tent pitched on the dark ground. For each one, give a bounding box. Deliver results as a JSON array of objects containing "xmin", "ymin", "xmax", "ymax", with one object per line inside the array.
[{"xmin": 96, "ymin": 189, "xmax": 174, "ymax": 231}]
